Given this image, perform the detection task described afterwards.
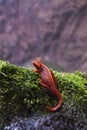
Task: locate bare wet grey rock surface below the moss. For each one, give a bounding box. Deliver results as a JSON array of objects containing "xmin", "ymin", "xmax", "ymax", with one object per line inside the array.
[{"xmin": 4, "ymin": 112, "xmax": 87, "ymax": 130}]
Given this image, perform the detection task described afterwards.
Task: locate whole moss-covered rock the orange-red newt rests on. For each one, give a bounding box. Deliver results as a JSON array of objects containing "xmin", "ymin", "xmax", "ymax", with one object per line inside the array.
[{"xmin": 0, "ymin": 60, "xmax": 87, "ymax": 130}]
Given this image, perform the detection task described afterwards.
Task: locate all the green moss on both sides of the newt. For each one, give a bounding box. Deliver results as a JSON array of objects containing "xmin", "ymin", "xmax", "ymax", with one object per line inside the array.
[{"xmin": 0, "ymin": 60, "xmax": 87, "ymax": 128}]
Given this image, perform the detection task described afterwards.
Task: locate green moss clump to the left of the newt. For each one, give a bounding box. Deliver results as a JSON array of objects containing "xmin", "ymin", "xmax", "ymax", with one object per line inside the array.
[{"xmin": 0, "ymin": 60, "xmax": 48, "ymax": 127}]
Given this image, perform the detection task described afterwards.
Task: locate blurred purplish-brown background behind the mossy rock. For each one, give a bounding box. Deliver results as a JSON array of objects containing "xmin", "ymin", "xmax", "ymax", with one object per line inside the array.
[{"xmin": 0, "ymin": 0, "xmax": 87, "ymax": 72}]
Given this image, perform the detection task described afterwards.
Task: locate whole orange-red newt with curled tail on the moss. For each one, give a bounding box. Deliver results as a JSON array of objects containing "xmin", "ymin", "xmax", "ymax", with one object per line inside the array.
[{"xmin": 32, "ymin": 58, "xmax": 63, "ymax": 111}]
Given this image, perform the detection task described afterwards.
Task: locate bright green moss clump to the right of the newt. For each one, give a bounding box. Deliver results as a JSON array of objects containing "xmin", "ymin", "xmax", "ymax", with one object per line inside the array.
[{"xmin": 54, "ymin": 72, "xmax": 87, "ymax": 109}]
